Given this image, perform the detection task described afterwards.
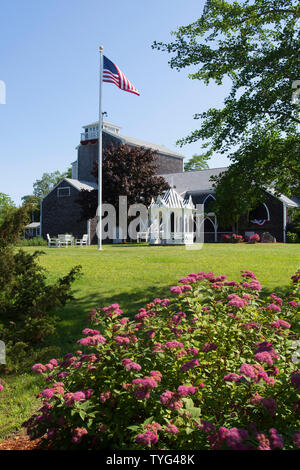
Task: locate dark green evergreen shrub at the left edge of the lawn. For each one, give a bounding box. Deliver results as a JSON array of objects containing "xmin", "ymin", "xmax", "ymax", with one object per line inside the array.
[{"xmin": 0, "ymin": 205, "xmax": 80, "ymax": 370}]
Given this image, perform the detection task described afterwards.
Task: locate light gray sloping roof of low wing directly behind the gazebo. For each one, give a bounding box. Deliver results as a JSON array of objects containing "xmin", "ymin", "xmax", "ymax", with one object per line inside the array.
[{"xmin": 160, "ymin": 167, "xmax": 227, "ymax": 195}]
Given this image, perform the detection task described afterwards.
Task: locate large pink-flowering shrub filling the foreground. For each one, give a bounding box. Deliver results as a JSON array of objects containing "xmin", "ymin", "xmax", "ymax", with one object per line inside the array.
[{"xmin": 24, "ymin": 270, "xmax": 300, "ymax": 450}]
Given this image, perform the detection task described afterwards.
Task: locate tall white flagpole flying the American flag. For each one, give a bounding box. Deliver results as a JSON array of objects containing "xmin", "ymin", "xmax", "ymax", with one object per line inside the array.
[{"xmin": 97, "ymin": 46, "xmax": 103, "ymax": 250}]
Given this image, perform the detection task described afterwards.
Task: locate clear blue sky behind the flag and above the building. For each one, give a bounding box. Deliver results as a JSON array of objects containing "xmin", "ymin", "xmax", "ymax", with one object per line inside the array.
[{"xmin": 0, "ymin": 0, "xmax": 228, "ymax": 204}]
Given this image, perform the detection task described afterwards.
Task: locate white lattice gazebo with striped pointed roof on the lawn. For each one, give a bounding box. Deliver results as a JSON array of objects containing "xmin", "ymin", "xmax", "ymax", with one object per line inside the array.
[{"xmin": 149, "ymin": 188, "xmax": 196, "ymax": 245}]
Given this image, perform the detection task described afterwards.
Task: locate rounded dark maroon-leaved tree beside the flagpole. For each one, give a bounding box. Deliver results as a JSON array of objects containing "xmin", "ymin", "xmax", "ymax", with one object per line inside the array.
[{"xmin": 78, "ymin": 144, "xmax": 169, "ymax": 219}]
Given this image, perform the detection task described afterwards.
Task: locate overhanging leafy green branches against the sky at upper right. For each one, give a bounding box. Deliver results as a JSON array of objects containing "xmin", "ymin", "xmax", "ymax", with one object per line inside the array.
[{"xmin": 153, "ymin": 0, "xmax": 300, "ymax": 210}]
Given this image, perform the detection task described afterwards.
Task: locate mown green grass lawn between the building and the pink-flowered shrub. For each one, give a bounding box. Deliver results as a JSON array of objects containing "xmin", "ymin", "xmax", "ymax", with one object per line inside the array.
[{"xmin": 0, "ymin": 244, "xmax": 300, "ymax": 438}]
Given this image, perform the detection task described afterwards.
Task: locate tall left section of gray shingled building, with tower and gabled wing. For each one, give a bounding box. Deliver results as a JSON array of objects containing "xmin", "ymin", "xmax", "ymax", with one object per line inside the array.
[{"xmin": 41, "ymin": 121, "xmax": 184, "ymax": 243}]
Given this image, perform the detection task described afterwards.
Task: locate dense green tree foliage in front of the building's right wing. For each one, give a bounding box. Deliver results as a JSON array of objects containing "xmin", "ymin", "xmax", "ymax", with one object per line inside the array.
[{"xmin": 213, "ymin": 127, "xmax": 300, "ymax": 228}]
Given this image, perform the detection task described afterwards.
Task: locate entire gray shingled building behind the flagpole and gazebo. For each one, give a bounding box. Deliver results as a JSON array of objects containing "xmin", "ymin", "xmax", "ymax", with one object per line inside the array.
[{"xmin": 41, "ymin": 122, "xmax": 299, "ymax": 243}]
